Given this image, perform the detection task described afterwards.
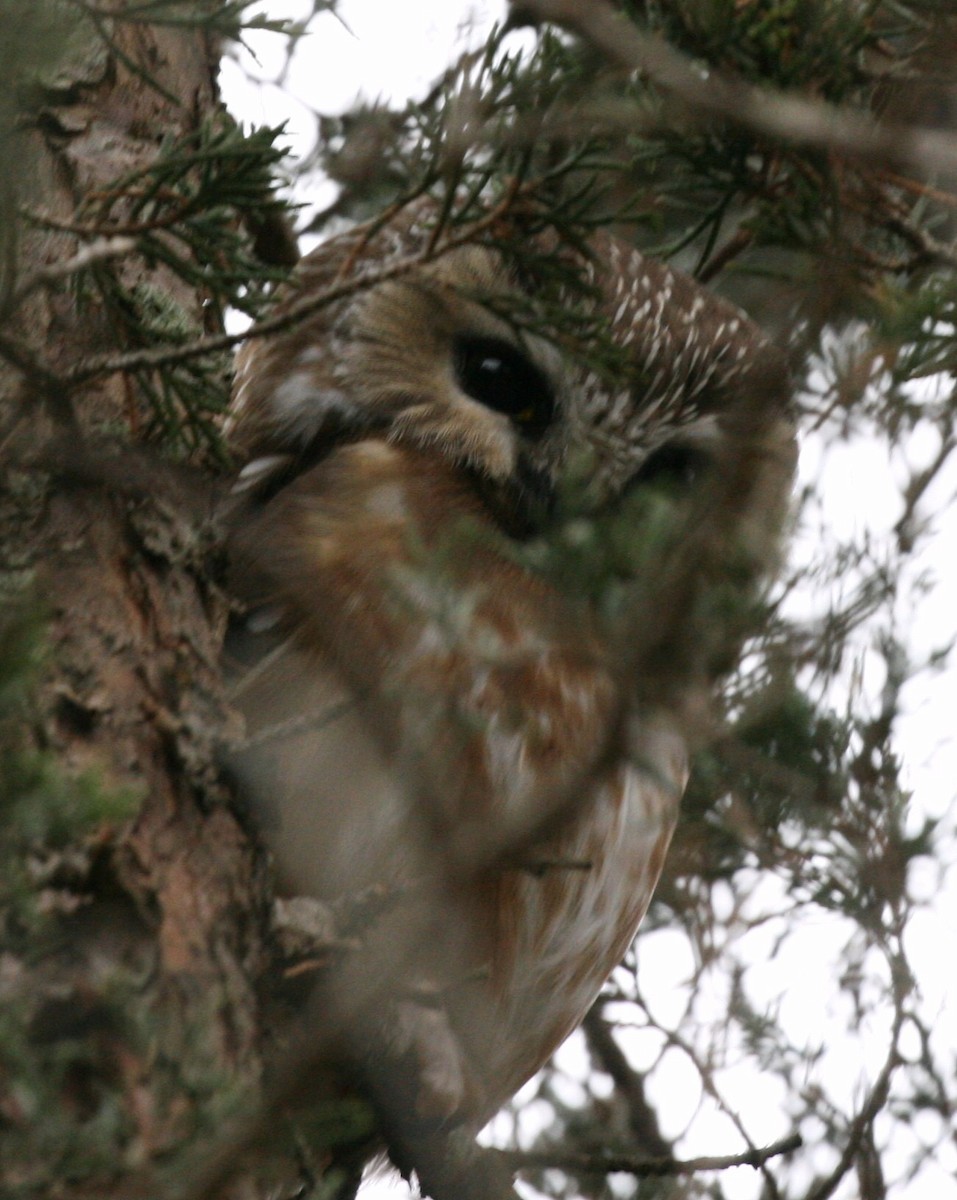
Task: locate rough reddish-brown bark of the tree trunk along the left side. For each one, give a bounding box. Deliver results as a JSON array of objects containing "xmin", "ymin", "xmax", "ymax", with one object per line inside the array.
[{"xmin": 0, "ymin": 10, "xmax": 264, "ymax": 1196}]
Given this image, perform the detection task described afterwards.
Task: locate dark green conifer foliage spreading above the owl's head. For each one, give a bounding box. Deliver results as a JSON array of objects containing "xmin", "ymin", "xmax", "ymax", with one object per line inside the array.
[{"xmin": 317, "ymin": 0, "xmax": 947, "ymax": 386}]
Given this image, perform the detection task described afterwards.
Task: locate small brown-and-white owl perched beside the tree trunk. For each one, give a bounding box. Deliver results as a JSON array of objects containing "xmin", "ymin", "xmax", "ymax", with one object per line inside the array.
[{"xmin": 229, "ymin": 204, "xmax": 793, "ymax": 1124}]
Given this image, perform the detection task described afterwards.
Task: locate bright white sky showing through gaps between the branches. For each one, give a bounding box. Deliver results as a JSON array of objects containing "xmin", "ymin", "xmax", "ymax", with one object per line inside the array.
[{"xmin": 222, "ymin": 0, "xmax": 957, "ymax": 1200}]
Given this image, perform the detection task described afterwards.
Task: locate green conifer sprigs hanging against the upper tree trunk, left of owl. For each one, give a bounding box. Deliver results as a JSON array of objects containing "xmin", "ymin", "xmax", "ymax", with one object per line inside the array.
[{"xmin": 25, "ymin": 116, "xmax": 296, "ymax": 458}]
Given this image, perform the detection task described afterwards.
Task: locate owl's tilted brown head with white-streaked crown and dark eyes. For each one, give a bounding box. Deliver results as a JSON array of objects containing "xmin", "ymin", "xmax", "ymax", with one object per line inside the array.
[{"xmin": 228, "ymin": 206, "xmax": 789, "ymax": 530}]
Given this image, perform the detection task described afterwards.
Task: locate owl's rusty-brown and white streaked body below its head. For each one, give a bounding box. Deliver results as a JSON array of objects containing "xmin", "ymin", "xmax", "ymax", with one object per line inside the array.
[{"xmin": 225, "ymin": 442, "xmax": 686, "ymax": 1115}]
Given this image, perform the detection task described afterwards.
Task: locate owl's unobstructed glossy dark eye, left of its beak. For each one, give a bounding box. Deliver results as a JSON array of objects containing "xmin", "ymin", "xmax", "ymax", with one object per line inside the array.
[{"xmin": 453, "ymin": 337, "xmax": 555, "ymax": 438}]
